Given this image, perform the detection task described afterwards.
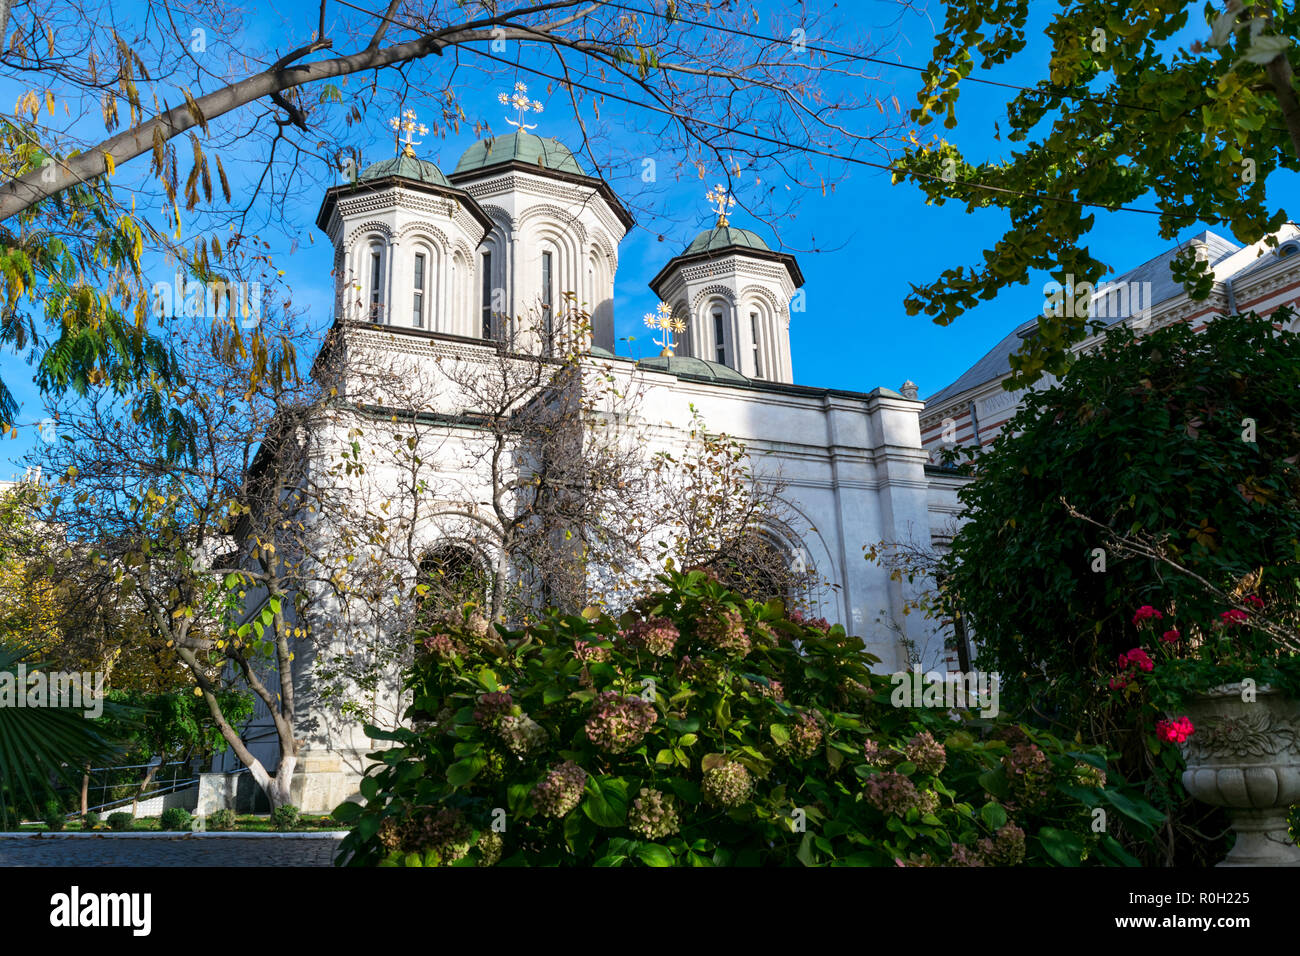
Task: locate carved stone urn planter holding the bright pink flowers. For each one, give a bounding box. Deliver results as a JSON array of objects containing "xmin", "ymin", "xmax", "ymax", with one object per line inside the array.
[{"xmin": 1180, "ymin": 684, "xmax": 1300, "ymax": 866}]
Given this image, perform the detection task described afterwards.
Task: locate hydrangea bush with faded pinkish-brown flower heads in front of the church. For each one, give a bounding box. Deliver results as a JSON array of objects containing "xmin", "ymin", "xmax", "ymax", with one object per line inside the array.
[{"xmin": 334, "ymin": 571, "xmax": 1158, "ymax": 866}]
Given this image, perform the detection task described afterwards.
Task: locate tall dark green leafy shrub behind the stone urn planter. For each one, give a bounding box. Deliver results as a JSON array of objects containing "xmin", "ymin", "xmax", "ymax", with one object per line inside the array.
[{"xmin": 943, "ymin": 310, "xmax": 1300, "ymax": 865}]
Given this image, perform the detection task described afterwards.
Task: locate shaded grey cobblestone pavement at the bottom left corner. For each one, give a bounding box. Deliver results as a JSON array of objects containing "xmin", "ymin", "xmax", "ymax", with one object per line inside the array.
[{"xmin": 0, "ymin": 832, "xmax": 346, "ymax": 866}]
